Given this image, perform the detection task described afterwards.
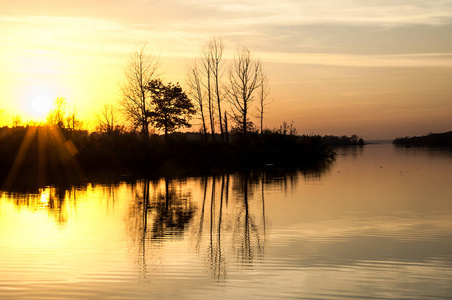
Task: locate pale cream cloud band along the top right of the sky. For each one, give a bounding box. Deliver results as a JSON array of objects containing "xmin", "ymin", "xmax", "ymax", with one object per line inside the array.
[{"xmin": 160, "ymin": 0, "xmax": 452, "ymax": 29}]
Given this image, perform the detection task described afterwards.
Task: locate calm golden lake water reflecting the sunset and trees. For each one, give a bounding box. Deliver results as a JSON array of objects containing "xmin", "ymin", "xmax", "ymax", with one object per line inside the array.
[{"xmin": 0, "ymin": 145, "xmax": 452, "ymax": 299}]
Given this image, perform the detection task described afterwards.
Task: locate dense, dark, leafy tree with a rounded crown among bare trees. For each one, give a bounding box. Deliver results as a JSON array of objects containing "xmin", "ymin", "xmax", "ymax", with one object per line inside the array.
[{"xmin": 146, "ymin": 79, "xmax": 196, "ymax": 138}]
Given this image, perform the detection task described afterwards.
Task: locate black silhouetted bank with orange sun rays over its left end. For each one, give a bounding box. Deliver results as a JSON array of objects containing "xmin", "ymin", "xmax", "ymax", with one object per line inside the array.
[{"xmin": 0, "ymin": 126, "xmax": 340, "ymax": 185}]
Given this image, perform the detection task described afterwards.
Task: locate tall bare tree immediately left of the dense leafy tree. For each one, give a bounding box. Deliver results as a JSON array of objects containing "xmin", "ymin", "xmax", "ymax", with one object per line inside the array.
[{"xmin": 120, "ymin": 44, "xmax": 159, "ymax": 138}]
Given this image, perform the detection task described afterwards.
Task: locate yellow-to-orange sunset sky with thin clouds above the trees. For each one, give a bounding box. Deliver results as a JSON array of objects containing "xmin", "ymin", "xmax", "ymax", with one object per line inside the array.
[{"xmin": 0, "ymin": 0, "xmax": 452, "ymax": 139}]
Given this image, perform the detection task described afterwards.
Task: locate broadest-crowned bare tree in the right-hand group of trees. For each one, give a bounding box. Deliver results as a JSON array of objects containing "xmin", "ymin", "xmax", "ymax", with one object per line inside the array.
[{"xmin": 227, "ymin": 47, "xmax": 261, "ymax": 135}]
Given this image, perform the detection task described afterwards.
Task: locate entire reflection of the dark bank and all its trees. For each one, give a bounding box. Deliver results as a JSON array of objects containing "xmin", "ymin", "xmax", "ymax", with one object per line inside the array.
[{"xmin": 0, "ymin": 159, "xmax": 328, "ymax": 283}]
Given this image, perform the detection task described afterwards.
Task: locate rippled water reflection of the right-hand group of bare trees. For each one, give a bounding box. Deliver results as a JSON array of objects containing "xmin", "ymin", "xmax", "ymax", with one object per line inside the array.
[{"xmin": 194, "ymin": 173, "xmax": 265, "ymax": 282}]
